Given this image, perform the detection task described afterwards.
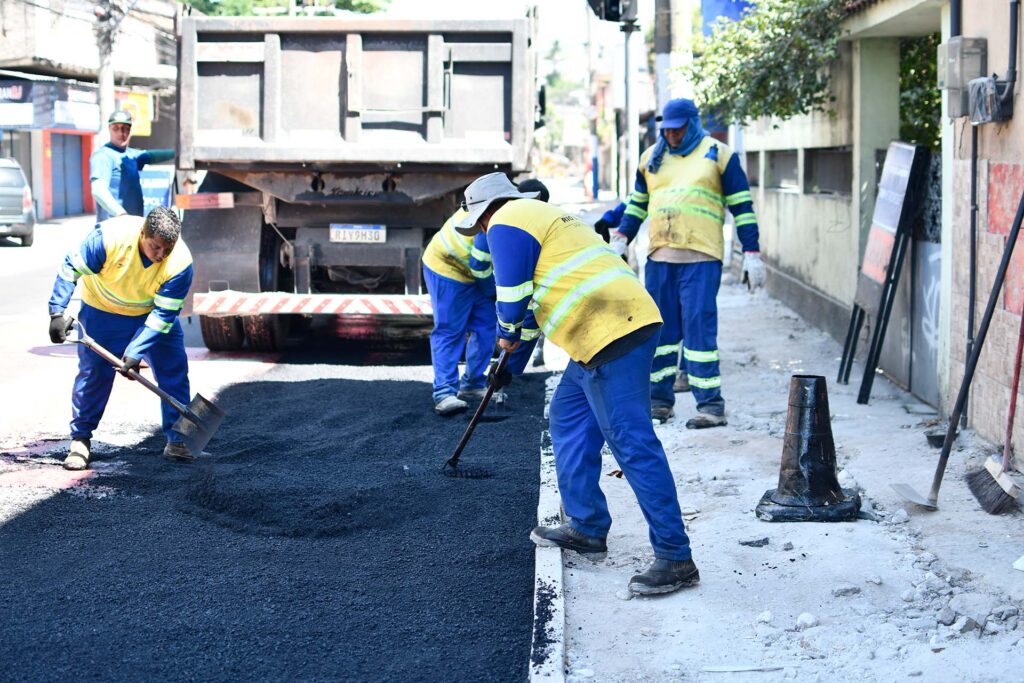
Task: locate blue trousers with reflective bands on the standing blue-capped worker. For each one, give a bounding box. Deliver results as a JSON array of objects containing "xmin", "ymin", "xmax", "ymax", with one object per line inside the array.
[{"xmin": 644, "ymin": 261, "xmax": 725, "ymax": 415}]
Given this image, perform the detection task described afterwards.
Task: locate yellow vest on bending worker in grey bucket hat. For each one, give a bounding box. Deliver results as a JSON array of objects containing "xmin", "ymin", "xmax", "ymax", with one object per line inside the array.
[{"xmin": 490, "ymin": 200, "xmax": 662, "ymax": 364}]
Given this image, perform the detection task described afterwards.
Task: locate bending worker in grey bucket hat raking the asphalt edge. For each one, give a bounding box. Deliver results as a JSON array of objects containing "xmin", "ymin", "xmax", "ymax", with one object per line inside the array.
[{"xmin": 456, "ymin": 173, "xmax": 699, "ymax": 595}]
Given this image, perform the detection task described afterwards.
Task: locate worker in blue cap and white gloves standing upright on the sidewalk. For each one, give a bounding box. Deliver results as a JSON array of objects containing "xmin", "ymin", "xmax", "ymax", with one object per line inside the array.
[{"xmin": 611, "ymin": 98, "xmax": 765, "ymax": 429}]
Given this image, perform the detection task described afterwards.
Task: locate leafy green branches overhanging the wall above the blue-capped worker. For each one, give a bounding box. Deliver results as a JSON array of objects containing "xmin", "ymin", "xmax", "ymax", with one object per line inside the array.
[{"xmin": 684, "ymin": 0, "xmax": 844, "ymax": 123}]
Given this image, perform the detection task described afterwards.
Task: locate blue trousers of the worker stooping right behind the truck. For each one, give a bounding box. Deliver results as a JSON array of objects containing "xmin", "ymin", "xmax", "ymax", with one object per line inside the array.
[{"xmin": 423, "ymin": 266, "xmax": 498, "ymax": 403}]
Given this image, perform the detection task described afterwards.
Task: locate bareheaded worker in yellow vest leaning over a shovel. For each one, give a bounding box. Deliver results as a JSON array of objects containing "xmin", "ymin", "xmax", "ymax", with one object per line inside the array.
[{"xmin": 49, "ymin": 207, "xmax": 193, "ymax": 470}]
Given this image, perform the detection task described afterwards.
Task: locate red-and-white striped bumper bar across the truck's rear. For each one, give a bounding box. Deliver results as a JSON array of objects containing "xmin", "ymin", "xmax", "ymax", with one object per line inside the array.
[{"xmin": 193, "ymin": 291, "xmax": 433, "ymax": 316}]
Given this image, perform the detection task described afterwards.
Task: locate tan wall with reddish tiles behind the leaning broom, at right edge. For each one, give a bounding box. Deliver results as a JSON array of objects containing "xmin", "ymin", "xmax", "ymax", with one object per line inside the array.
[{"xmin": 943, "ymin": 0, "xmax": 1024, "ymax": 458}]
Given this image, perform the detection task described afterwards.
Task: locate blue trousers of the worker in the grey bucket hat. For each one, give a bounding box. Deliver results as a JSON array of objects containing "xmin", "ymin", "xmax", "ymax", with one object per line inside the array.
[{"xmin": 550, "ymin": 335, "xmax": 690, "ymax": 560}]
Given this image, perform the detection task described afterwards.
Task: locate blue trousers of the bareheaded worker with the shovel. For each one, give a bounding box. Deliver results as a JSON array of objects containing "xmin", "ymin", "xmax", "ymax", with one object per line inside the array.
[{"xmin": 71, "ymin": 303, "xmax": 188, "ymax": 442}]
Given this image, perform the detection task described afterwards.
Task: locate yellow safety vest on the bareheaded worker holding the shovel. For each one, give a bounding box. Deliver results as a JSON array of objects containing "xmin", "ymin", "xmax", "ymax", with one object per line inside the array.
[{"xmin": 79, "ymin": 216, "xmax": 191, "ymax": 316}]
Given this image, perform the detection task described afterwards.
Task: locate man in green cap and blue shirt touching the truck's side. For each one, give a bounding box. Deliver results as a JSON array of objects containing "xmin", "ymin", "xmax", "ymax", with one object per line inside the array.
[{"xmin": 89, "ymin": 112, "xmax": 174, "ymax": 227}]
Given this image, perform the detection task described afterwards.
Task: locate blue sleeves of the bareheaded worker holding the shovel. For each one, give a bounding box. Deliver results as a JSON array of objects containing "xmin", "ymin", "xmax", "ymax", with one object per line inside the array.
[{"xmin": 49, "ymin": 227, "xmax": 193, "ymax": 358}]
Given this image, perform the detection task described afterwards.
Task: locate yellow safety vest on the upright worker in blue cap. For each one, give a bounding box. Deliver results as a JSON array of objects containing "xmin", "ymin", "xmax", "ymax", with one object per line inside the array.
[{"xmin": 640, "ymin": 136, "xmax": 732, "ymax": 261}]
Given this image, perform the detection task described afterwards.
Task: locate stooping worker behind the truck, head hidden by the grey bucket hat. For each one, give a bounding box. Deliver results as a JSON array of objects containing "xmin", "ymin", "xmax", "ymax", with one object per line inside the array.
[{"xmin": 423, "ymin": 180, "xmax": 548, "ymax": 416}]
